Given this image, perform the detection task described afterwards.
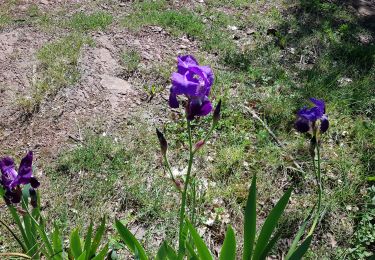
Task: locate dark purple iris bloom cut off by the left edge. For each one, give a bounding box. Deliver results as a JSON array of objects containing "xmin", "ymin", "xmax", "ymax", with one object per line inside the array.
[{"xmin": 0, "ymin": 151, "xmax": 40, "ymax": 203}]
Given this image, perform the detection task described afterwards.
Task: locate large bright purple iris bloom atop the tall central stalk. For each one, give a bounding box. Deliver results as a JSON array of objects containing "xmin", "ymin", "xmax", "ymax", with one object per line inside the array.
[{"xmin": 169, "ymin": 55, "xmax": 214, "ymax": 120}]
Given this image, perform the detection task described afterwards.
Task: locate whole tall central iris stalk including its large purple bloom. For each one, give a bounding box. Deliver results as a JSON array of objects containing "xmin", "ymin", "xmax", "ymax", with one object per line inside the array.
[{"xmin": 167, "ymin": 55, "xmax": 220, "ymax": 255}]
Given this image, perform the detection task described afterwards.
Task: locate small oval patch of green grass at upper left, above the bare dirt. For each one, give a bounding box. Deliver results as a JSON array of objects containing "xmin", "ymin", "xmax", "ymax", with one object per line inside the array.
[{"xmin": 67, "ymin": 11, "xmax": 113, "ymax": 32}]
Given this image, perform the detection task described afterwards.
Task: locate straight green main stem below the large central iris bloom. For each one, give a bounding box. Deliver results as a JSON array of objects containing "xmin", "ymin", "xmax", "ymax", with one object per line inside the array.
[{"xmin": 178, "ymin": 120, "xmax": 194, "ymax": 254}]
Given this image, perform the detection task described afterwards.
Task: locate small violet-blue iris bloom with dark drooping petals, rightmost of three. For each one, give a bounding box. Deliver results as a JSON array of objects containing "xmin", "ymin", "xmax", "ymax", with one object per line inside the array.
[{"xmin": 295, "ymin": 98, "xmax": 329, "ymax": 133}]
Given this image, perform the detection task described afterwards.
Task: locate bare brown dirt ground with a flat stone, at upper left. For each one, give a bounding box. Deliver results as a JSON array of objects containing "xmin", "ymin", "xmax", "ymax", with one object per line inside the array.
[{"xmin": 0, "ymin": 1, "xmax": 203, "ymax": 162}]
